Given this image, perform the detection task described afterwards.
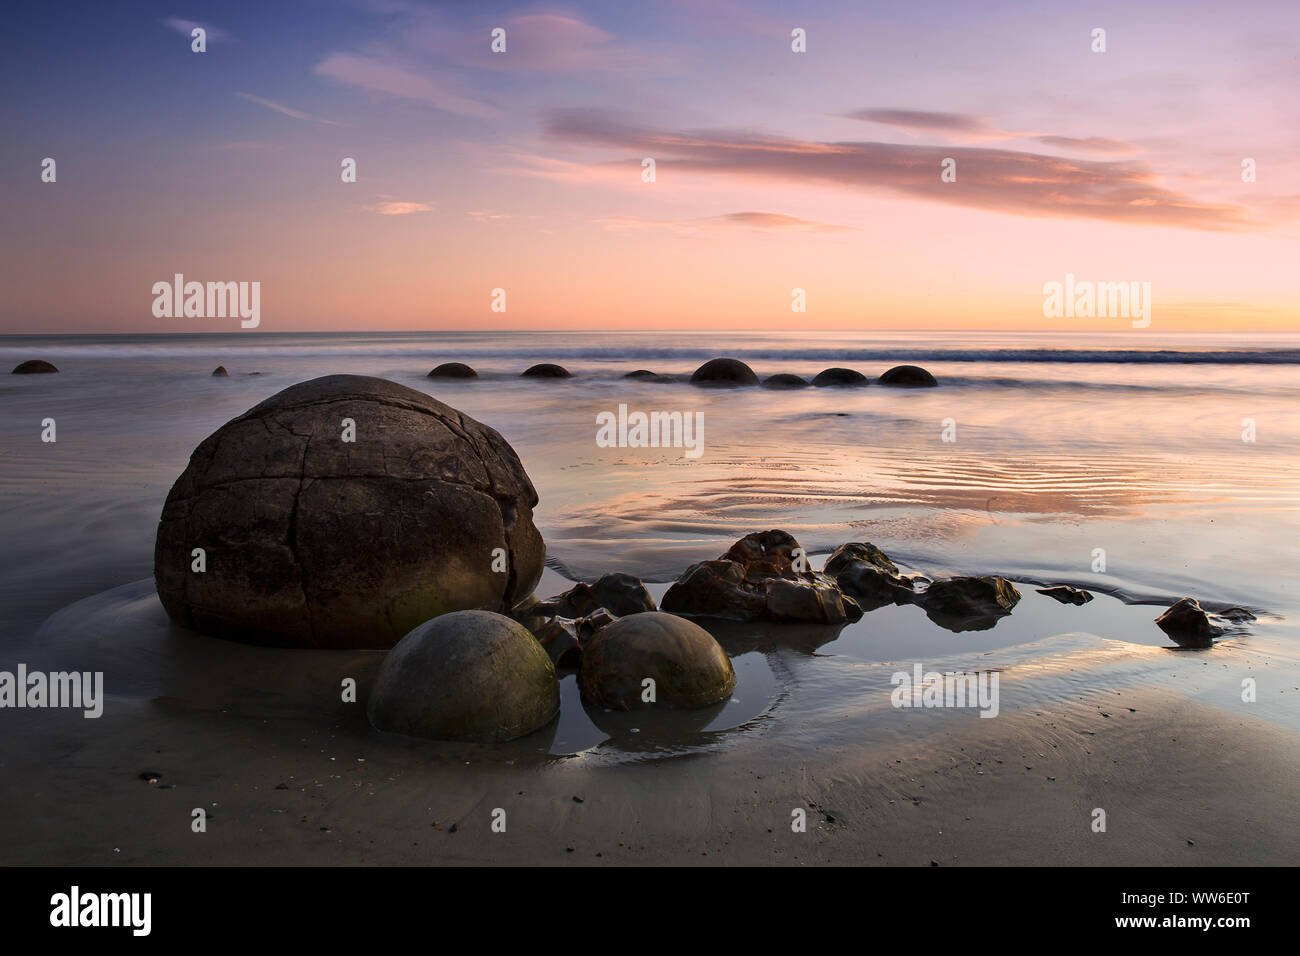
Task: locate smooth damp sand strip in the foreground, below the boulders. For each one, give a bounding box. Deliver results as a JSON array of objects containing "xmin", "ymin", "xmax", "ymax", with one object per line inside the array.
[{"xmin": 0, "ymin": 689, "xmax": 1300, "ymax": 866}]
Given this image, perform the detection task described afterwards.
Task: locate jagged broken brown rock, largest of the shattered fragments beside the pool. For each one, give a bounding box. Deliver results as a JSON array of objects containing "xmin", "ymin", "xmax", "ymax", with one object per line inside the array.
[{"xmin": 659, "ymin": 531, "xmax": 862, "ymax": 624}]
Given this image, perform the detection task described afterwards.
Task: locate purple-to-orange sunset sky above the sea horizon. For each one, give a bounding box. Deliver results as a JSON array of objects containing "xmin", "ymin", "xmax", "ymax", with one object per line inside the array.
[{"xmin": 0, "ymin": 0, "xmax": 1300, "ymax": 334}]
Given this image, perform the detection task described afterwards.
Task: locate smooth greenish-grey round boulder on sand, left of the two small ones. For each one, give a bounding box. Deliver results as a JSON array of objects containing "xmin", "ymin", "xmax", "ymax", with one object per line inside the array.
[{"xmin": 367, "ymin": 611, "xmax": 560, "ymax": 743}]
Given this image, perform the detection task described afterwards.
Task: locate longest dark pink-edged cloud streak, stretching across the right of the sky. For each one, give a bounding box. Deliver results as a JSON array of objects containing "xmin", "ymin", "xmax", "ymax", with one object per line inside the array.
[{"xmin": 546, "ymin": 111, "xmax": 1260, "ymax": 232}]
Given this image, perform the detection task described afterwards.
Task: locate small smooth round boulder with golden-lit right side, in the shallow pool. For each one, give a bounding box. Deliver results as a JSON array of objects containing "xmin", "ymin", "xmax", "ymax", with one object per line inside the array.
[{"xmin": 577, "ymin": 611, "xmax": 736, "ymax": 710}]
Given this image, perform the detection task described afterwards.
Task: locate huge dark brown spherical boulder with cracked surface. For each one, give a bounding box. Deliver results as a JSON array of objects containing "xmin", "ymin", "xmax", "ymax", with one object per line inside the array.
[{"xmin": 153, "ymin": 375, "xmax": 546, "ymax": 648}]
